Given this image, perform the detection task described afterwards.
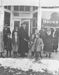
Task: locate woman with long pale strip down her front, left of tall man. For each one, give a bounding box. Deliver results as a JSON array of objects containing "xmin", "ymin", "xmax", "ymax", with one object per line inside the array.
[{"xmin": 12, "ymin": 27, "xmax": 19, "ymax": 57}]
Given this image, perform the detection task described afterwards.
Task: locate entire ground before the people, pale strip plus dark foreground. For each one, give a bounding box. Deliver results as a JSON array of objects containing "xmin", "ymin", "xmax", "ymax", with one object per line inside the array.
[{"xmin": 0, "ymin": 52, "xmax": 59, "ymax": 75}]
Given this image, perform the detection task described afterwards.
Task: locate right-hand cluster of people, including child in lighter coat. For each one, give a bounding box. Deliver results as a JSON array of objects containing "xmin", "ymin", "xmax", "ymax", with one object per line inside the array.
[{"xmin": 30, "ymin": 28, "xmax": 58, "ymax": 59}]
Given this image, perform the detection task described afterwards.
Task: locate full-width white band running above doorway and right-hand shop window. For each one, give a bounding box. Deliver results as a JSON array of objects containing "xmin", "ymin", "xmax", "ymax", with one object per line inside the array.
[{"xmin": 0, "ymin": 0, "xmax": 59, "ymax": 7}]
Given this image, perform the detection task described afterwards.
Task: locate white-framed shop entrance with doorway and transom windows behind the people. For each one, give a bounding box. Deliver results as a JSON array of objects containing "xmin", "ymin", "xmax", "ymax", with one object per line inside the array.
[{"xmin": 0, "ymin": 0, "xmax": 41, "ymax": 36}]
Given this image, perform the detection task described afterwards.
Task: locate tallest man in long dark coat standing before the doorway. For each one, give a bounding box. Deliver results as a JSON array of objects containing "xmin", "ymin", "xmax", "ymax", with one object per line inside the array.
[{"xmin": 18, "ymin": 24, "xmax": 29, "ymax": 57}]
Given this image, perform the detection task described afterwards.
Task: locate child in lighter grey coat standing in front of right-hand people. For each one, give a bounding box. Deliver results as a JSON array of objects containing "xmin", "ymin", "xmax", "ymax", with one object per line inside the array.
[{"xmin": 34, "ymin": 33, "xmax": 44, "ymax": 60}]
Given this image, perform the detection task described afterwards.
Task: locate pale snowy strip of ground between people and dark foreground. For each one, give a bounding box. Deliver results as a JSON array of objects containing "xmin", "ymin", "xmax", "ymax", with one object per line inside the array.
[{"xmin": 0, "ymin": 58, "xmax": 59, "ymax": 74}]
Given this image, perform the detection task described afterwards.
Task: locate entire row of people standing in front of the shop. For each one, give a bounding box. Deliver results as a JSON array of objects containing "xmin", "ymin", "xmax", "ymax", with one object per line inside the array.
[{"xmin": 0, "ymin": 24, "xmax": 58, "ymax": 59}]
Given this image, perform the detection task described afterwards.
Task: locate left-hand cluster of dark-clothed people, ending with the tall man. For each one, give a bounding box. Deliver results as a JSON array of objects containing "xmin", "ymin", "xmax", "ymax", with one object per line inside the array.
[{"xmin": 3, "ymin": 24, "xmax": 29, "ymax": 57}]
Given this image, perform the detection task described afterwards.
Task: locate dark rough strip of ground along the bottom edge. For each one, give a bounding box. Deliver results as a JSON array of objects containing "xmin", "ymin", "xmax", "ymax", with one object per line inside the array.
[{"xmin": 0, "ymin": 67, "xmax": 52, "ymax": 75}]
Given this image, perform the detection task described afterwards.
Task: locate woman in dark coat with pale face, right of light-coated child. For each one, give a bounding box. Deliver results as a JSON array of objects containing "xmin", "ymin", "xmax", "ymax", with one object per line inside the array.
[{"xmin": 44, "ymin": 28, "xmax": 53, "ymax": 58}]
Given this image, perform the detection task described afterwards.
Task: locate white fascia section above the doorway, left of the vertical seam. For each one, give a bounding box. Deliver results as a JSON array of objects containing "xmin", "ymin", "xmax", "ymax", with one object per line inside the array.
[{"xmin": 0, "ymin": 0, "xmax": 39, "ymax": 6}]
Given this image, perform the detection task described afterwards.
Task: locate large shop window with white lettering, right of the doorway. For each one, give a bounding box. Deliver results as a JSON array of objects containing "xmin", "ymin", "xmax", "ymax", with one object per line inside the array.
[{"xmin": 41, "ymin": 9, "xmax": 59, "ymax": 28}]
